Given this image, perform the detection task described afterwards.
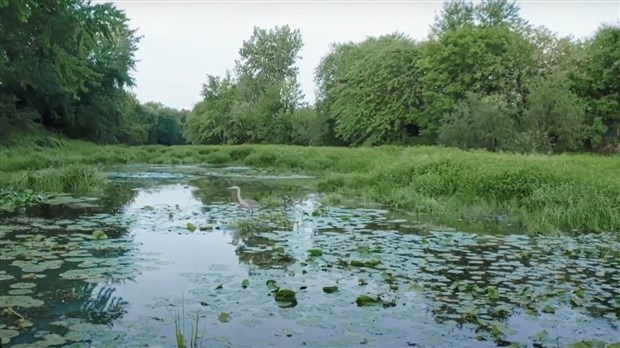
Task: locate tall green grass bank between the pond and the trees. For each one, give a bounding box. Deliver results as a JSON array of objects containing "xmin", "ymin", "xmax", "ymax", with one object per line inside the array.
[{"xmin": 0, "ymin": 136, "xmax": 620, "ymax": 232}]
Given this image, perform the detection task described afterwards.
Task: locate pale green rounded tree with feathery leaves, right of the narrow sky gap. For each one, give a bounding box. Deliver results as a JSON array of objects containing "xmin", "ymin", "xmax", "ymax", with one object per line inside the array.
[{"xmin": 329, "ymin": 34, "xmax": 427, "ymax": 145}]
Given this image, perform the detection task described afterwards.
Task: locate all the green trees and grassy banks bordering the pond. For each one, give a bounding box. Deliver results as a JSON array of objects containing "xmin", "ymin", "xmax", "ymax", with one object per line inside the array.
[{"xmin": 0, "ymin": 0, "xmax": 620, "ymax": 237}]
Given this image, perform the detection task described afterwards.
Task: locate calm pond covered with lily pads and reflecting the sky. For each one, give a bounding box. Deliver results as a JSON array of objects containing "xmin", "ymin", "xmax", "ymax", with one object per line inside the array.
[{"xmin": 0, "ymin": 166, "xmax": 620, "ymax": 347}]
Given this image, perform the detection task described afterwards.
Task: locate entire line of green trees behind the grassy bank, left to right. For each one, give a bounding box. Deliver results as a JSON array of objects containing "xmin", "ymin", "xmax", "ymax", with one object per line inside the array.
[{"xmin": 0, "ymin": 0, "xmax": 620, "ymax": 152}]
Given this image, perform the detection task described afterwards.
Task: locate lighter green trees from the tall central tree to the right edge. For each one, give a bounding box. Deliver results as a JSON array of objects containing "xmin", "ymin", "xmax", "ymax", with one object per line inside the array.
[{"xmin": 188, "ymin": 0, "xmax": 620, "ymax": 152}]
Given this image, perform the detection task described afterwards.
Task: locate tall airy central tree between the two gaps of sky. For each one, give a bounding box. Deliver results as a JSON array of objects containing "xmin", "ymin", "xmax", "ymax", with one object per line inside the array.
[{"xmin": 188, "ymin": 26, "xmax": 303, "ymax": 144}]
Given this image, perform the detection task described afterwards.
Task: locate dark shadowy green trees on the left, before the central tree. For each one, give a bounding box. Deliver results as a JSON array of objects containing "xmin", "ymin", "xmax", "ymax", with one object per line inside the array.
[{"xmin": 0, "ymin": 0, "xmax": 185, "ymax": 144}]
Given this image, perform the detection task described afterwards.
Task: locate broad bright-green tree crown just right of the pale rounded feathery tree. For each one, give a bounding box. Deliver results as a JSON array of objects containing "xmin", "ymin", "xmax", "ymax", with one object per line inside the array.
[{"xmin": 420, "ymin": 25, "xmax": 536, "ymax": 133}]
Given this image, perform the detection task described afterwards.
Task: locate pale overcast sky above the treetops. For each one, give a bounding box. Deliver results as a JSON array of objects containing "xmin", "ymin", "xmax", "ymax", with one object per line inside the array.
[{"xmin": 106, "ymin": 0, "xmax": 620, "ymax": 109}]
